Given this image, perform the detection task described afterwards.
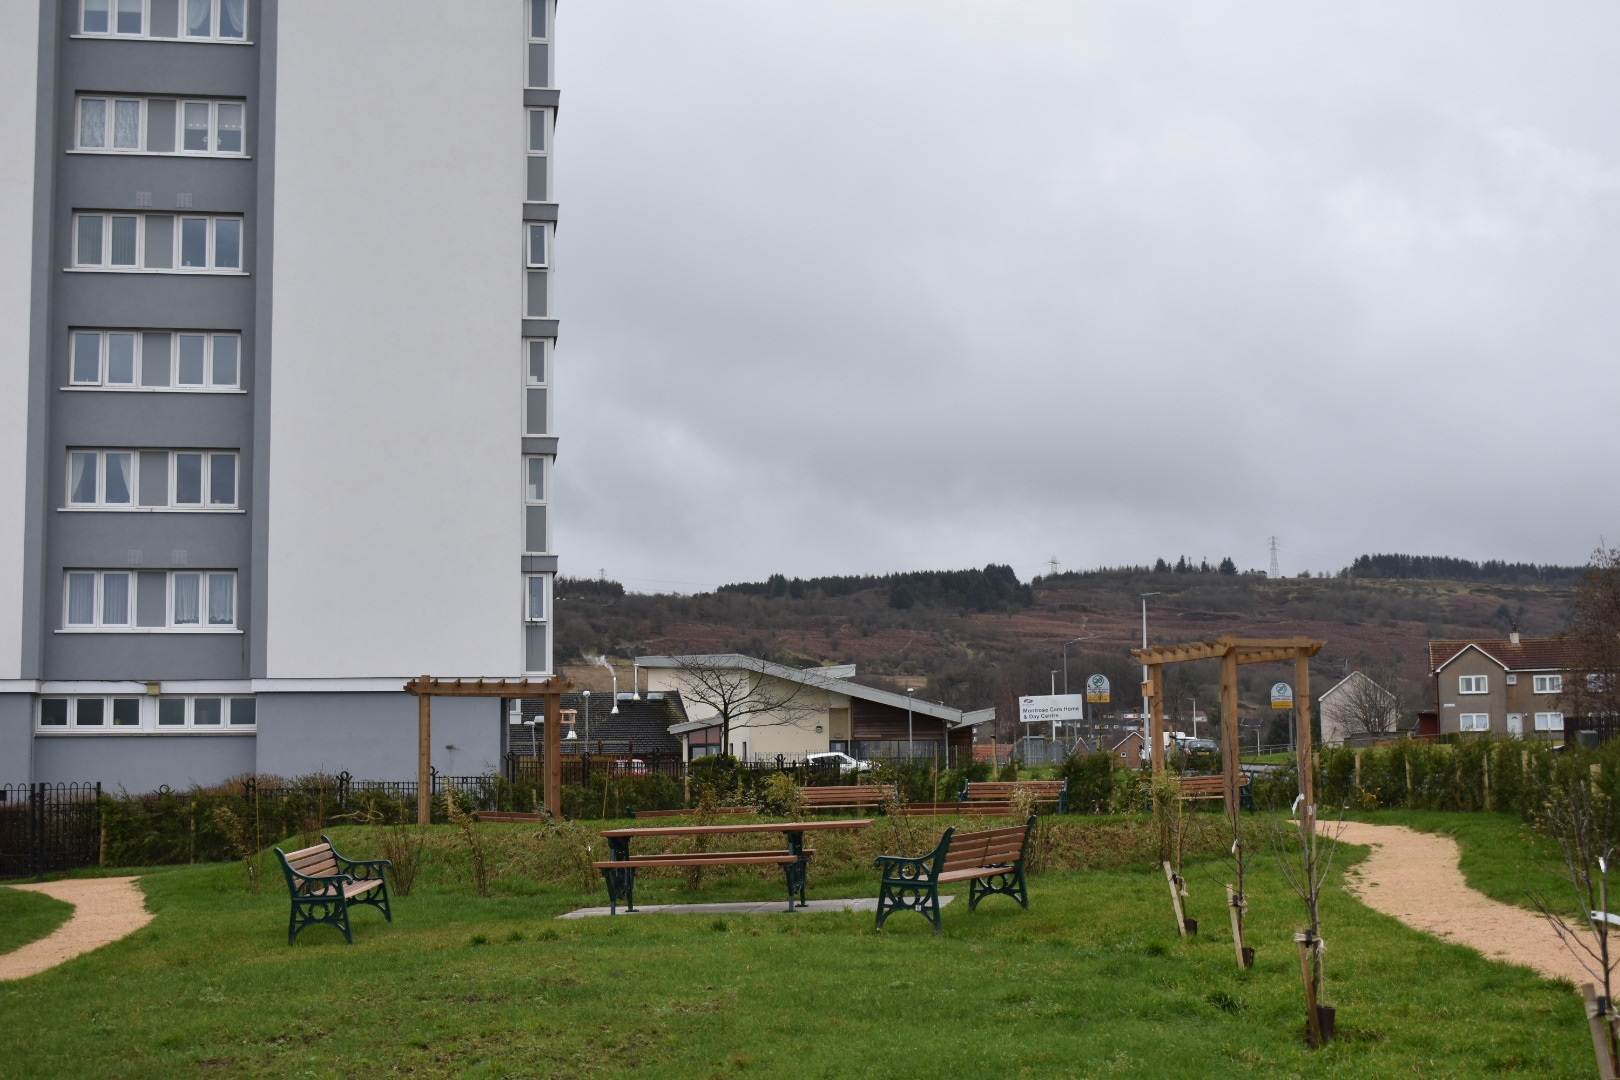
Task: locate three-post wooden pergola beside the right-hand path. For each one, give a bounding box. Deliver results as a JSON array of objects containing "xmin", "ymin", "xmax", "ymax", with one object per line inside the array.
[{"xmin": 1131, "ymin": 635, "xmax": 1325, "ymax": 814}]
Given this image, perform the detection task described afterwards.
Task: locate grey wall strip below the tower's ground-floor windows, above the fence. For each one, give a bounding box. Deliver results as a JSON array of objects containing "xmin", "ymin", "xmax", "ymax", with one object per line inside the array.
[{"xmin": 34, "ymin": 735, "xmax": 253, "ymax": 795}]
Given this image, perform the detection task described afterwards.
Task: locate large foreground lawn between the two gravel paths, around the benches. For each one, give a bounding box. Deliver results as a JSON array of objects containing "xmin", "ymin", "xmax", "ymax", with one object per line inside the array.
[{"xmin": 0, "ymin": 824, "xmax": 1591, "ymax": 1077}]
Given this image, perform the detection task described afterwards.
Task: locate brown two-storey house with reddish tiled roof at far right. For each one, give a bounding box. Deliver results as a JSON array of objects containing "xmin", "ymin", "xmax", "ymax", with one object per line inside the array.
[{"xmin": 1429, "ymin": 631, "xmax": 1580, "ymax": 740}]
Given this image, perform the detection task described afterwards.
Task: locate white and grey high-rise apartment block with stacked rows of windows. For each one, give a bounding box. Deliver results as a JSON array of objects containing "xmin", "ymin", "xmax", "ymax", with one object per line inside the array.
[{"xmin": 0, "ymin": 0, "xmax": 557, "ymax": 790}]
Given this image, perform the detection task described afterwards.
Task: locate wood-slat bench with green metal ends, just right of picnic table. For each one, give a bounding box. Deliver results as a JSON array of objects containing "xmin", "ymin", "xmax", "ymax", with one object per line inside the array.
[{"xmin": 876, "ymin": 814, "xmax": 1035, "ymax": 934}]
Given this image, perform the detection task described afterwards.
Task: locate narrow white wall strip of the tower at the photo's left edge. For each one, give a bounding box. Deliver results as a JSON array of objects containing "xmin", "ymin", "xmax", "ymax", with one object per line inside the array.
[{"xmin": 0, "ymin": 3, "xmax": 44, "ymax": 678}]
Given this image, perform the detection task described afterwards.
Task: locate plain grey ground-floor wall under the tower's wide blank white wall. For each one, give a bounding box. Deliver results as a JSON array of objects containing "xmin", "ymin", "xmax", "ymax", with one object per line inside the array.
[{"xmin": 258, "ymin": 693, "xmax": 502, "ymax": 780}]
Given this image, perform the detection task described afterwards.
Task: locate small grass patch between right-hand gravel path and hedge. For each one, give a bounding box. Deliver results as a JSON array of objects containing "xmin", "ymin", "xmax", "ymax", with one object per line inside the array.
[{"xmin": 1353, "ymin": 810, "xmax": 1580, "ymax": 915}]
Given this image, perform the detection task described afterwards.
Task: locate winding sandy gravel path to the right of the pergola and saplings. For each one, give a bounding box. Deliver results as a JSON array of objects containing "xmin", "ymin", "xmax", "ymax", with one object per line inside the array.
[{"xmin": 1320, "ymin": 821, "xmax": 1592, "ymax": 986}]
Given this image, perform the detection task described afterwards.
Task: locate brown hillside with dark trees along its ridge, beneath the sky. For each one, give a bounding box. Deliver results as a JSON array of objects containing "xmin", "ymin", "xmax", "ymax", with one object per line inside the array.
[{"xmin": 556, "ymin": 555, "xmax": 1584, "ymax": 744}]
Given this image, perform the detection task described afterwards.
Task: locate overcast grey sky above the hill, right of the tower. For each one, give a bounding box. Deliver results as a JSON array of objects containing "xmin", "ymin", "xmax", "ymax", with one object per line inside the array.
[{"xmin": 556, "ymin": 0, "xmax": 1620, "ymax": 591}]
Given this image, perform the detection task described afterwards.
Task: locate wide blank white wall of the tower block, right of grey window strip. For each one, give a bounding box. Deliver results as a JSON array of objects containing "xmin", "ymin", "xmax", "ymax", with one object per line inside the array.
[{"xmin": 266, "ymin": 0, "xmax": 525, "ymax": 678}]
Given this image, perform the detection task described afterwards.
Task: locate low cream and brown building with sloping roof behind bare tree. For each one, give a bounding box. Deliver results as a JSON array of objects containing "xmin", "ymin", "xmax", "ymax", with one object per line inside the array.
[{"xmin": 635, "ymin": 653, "xmax": 995, "ymax": 763}]
